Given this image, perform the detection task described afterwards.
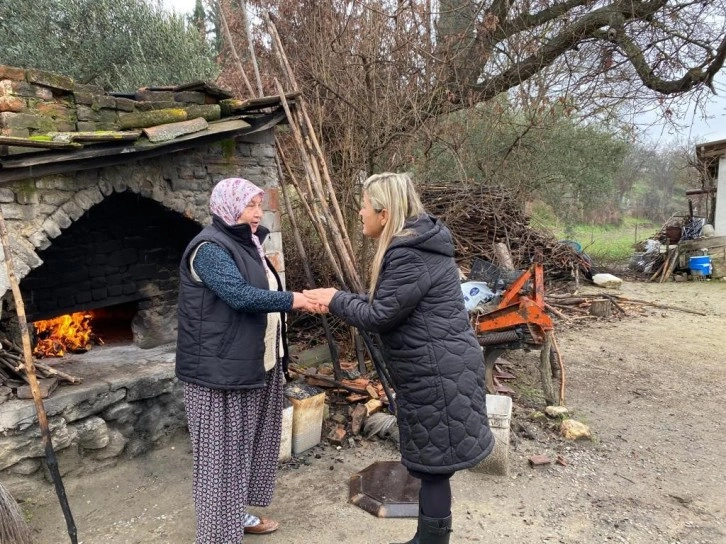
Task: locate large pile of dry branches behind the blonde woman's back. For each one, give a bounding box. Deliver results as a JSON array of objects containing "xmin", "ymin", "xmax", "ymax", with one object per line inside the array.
[{"xmin": 421, "ymin": 183, "xmax": 590, "ymax": 278}]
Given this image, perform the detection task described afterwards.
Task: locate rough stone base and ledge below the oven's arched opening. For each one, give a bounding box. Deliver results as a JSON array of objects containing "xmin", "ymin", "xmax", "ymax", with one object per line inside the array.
[{"xmin": 0, "ymin": 347, "xmax": 181, "ymax": 500}]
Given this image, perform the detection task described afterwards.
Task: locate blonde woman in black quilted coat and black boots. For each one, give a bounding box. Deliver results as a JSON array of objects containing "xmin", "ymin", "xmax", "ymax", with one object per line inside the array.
[{"xmin": 304, "ymin": 173, "xmax": 494, "ymax": 544}]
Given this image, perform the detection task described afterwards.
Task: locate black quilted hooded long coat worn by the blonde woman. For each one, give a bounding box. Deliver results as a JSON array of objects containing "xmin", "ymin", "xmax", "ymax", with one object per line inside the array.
[{"xmin": 330, "ymin": 212, "xmax": 494, "ymax": 473}]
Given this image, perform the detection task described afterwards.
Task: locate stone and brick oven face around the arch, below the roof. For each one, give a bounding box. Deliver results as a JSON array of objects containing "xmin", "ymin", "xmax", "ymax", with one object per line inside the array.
[{"xmin": 0, "ymin": 131, "xmax": 284, "ymax": 306}]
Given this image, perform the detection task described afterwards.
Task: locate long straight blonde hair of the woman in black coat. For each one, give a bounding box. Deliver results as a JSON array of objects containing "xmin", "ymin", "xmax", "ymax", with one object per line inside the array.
[{"xmin": 363, "ymin": 172, "xmax": 425, "ymax": 301}]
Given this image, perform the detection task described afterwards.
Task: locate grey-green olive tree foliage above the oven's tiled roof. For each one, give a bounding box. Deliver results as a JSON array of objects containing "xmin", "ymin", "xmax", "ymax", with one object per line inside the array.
[{"xmin": 0, "ymin": 0, "xmax": 218, "ymax": 91}]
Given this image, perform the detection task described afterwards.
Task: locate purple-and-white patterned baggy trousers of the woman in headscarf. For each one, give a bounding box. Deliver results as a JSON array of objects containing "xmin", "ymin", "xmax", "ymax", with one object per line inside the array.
[{"xmin": 184, "ymin": 363, "xmax": 284, "ymax": 544}]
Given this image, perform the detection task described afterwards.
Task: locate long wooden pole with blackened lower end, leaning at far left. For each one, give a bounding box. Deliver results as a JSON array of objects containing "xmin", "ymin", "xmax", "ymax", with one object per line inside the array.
[{"xmin": 0, "ymin": 212, "xmax": 78, "ymax": 544}]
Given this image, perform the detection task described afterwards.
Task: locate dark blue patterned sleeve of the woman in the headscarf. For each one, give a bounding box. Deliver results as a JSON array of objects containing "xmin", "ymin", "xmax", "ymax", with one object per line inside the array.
[{"xmin": 194, "ymin": 243, "xmax": 293, "ymax": 313}]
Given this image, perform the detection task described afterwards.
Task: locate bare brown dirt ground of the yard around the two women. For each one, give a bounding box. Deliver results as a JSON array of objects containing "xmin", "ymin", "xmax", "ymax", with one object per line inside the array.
[{"xmin": 19, "ymin": 281, "xmax": 726, "ymax": 544}]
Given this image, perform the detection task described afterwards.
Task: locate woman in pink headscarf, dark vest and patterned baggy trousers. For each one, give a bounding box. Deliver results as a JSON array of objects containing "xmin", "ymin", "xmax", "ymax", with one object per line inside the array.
[{"xmin": 176, "ymin": 178, "xmax": 314, "ymax": 544}]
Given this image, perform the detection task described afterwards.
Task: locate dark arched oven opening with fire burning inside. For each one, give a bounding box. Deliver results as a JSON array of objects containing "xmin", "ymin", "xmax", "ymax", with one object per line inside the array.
[{"xmin": 3, "ymin": 191, "xmax": 201, "ymax": 357}]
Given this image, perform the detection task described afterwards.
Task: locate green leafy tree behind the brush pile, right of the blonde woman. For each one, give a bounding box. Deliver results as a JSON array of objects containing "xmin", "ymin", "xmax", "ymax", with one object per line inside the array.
[{"xmin": 413, "ymin": 100, "xmax": 632, "ymax": 223}]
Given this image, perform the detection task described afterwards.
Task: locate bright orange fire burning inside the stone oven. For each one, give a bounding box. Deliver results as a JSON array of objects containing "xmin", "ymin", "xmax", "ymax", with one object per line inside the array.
[{"xmin": 33, "ymin": 312, "xmax": 99, "ymax": 357}]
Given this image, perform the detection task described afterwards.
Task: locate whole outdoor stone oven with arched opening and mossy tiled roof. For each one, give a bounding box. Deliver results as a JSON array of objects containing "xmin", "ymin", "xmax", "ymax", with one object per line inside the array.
[{"xmin": 0, "ymin": 66, "xmax": 284, "ymax": 499}]
